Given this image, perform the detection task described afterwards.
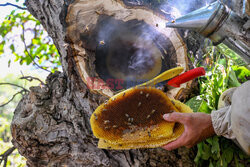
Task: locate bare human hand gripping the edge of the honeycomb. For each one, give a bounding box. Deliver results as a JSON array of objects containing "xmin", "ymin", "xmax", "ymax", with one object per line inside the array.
[{"xmin": 163, "ymin": 112, "xmax": 215, "ymax": 151}]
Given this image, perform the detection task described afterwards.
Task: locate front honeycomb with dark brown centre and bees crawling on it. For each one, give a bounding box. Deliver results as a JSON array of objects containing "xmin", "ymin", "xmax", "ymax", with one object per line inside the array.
[{"xmin": 90, "ymin": 87, "xmax": 182, "ymax": 144}]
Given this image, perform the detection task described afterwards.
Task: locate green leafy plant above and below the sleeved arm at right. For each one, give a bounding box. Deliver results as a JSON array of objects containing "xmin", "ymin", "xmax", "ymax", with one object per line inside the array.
[{"xmin": 186, "ymin": 45, "xmax": 250, "ymax": 167}]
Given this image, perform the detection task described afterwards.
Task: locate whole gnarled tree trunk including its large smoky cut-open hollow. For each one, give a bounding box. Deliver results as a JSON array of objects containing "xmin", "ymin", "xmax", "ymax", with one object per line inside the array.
[{"xmin": 11, "ymin": 0, "xmax": 202, "ymax": 167}]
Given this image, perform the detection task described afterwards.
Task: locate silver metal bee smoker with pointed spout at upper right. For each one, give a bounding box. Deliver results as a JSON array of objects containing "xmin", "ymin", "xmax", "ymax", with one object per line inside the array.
[{"xmin": 166, "ymin": 1, "xmax": 250, "ymax": 64}]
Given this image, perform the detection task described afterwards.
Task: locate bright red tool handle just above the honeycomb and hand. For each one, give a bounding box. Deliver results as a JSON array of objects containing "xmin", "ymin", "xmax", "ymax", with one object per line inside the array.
[{"xmin": 168, "ymin": 67, "xmax": 206, "ymax": 87}]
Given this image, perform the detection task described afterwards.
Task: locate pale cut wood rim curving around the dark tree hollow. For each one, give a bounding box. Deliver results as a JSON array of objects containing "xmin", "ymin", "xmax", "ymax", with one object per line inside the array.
[{"xmin": 66, "ymin": 0, "xmax": 188, "ymax": 97}]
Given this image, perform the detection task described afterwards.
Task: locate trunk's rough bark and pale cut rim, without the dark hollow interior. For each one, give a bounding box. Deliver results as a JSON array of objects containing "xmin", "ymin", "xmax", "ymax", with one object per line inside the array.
[{"xmin": 11, "ymin": 0, "xmax": 201, "ymax": 167}]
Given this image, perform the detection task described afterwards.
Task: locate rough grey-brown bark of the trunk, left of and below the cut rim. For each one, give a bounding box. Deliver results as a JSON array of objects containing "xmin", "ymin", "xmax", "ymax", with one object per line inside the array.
[{"xmin": 11, "ymin": 0, "xmax": 203, "ymax": 167}]
